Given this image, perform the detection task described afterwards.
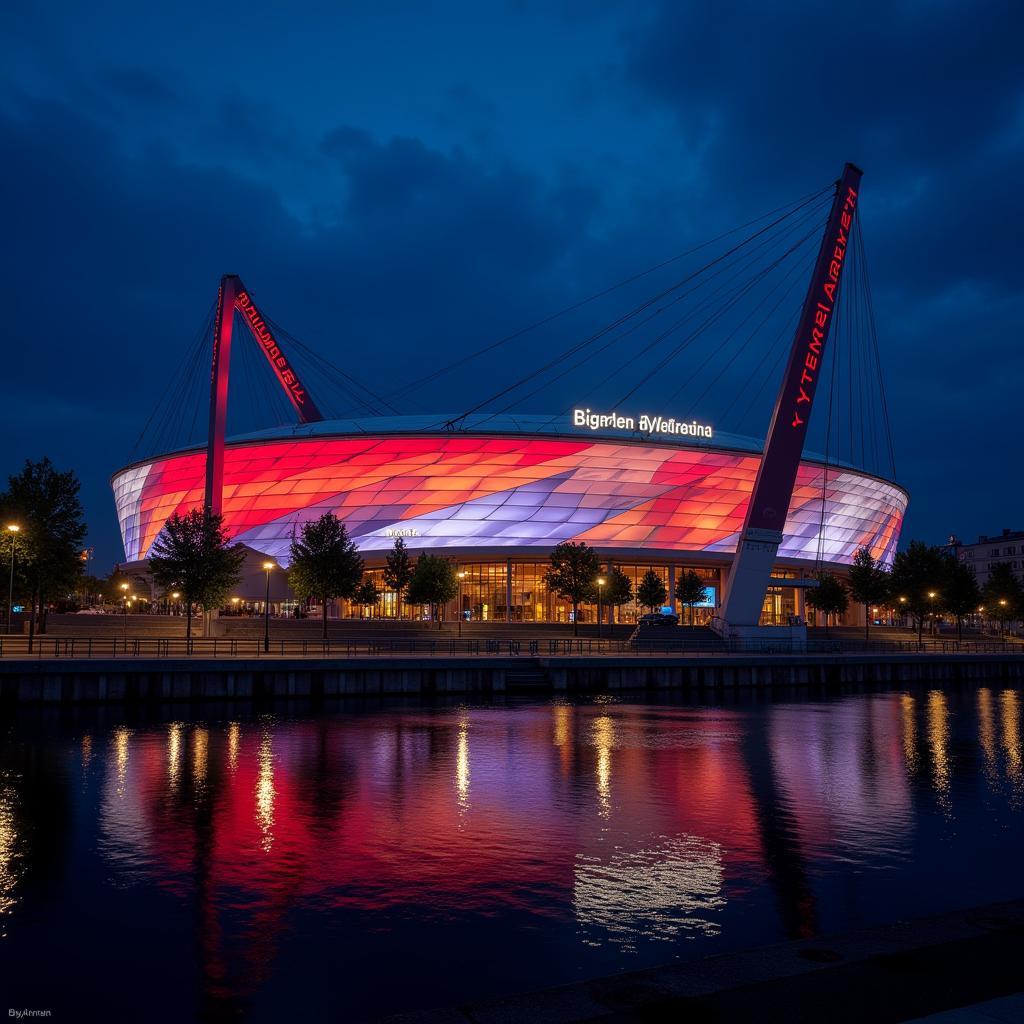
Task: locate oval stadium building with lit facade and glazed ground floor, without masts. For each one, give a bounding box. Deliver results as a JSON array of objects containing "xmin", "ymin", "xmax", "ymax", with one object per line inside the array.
[{"xmin": 113, "ymin": 416, "xmax": 907, "ymax": 622}]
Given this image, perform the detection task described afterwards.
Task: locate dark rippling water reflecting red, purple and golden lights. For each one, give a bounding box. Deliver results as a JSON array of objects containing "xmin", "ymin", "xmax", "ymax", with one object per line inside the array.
[{"xmin": 0, "ymin": 685, "xmax": 1024, "ymax": 1021}]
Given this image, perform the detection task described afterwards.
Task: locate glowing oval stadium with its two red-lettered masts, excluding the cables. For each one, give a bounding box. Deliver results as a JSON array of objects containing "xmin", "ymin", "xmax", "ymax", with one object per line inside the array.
[{"xmin": 113, "ymin": 172, "xmax": 907, "ymax": 626}]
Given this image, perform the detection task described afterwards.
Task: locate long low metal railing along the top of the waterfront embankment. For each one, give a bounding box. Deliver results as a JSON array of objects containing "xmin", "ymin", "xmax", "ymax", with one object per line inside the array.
[{"xmin": 0, "ymin": 636, "xmax": 1024, "ymax": 659}]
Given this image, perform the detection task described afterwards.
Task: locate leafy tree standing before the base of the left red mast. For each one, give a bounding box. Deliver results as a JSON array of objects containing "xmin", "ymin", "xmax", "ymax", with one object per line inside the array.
[{"xmin": 150, "ymin": 509, "xmax": 246, "ymax": 639}]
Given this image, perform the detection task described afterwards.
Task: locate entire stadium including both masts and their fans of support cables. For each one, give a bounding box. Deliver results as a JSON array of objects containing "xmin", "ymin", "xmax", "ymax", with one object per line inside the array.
[{"xmin": 112, "ymin": 171, "xmax": 907, "ymax": 635}]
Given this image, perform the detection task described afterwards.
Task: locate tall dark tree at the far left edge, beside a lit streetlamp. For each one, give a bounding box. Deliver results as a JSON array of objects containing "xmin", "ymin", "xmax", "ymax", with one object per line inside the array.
[{"xmin": 0, "ymin": 459, "xmax": 86, "ymax": 650}]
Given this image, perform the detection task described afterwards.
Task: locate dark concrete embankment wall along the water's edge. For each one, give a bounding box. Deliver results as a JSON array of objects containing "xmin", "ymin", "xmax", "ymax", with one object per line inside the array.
[{"xmin": 0, "ymin": 653, "xmax": 1024, "ymax": 703}]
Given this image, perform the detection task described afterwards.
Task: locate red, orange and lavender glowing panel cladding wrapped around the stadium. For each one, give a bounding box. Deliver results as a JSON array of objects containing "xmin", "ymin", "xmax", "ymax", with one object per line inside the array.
[{"xmin": 113, "ymin": 433, "xmax": 906, "ymax": 569}]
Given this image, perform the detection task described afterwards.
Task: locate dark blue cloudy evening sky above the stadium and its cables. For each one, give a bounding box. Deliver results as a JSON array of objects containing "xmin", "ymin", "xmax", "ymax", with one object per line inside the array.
[{"xmin": 0, "ymin": 0, "xmax": 1024, "ymax": 569}]
